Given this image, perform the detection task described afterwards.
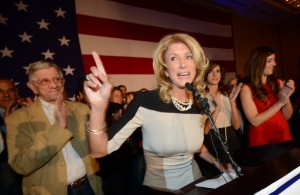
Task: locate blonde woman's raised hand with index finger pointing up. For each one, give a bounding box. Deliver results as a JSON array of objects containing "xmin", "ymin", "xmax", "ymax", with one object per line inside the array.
[{"xmin": 84, "ymin": 51, "xmax": 112, "ymax": 108}]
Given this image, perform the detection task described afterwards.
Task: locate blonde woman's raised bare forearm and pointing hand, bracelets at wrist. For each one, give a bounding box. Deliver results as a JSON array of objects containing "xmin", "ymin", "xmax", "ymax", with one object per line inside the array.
[{"xmin": 84, "ymin": 52, "xmax": 112, "ymax": 158}]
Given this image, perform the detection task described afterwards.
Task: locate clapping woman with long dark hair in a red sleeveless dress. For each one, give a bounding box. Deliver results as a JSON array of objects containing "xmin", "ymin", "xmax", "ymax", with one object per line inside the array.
[{"xmin": 240, "ymin": 47, "xmax": 295, "ymax": 147}]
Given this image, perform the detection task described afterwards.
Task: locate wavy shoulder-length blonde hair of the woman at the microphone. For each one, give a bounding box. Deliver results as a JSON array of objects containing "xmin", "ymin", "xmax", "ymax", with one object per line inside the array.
[{"xmin": 153, "ymin": 33, "xmax": 209, "ymax": 103}]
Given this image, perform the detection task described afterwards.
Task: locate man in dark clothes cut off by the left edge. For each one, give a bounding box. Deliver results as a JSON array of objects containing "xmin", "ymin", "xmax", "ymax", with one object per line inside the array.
[{"xmin": 0, "ymin": 77, "xmax": 24, "ymax": 195}]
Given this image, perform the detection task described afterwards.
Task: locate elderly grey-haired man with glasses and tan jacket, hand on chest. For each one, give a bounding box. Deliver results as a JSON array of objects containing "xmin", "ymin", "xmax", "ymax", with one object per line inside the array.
[{"xmin": 5, "ymin": 61, "xmax": 102, "ymax": 195}]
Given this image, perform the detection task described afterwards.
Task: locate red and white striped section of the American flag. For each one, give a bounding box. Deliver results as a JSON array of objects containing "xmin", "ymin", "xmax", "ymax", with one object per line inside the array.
[{"xmin": 75, "ymin": 0, "xmax": 235, "ymax": 91}]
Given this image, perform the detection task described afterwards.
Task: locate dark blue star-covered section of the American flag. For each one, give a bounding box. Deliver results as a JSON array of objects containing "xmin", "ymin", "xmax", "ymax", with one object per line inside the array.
[{"xmin": 0, "ymin": 0, "xmax": 84, "ymax": 97}]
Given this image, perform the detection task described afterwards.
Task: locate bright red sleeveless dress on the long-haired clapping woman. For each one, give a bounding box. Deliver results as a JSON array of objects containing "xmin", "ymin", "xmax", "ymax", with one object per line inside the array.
[{"xmin": 248, "ymin": 84, "xmax": 292, "ymax": 147}]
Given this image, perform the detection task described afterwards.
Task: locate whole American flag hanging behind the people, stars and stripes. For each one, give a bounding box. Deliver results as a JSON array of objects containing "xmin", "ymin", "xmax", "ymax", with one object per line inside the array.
[{"xmin": 0, "ymin": 0, "xmax": 236, "ymax": 96}]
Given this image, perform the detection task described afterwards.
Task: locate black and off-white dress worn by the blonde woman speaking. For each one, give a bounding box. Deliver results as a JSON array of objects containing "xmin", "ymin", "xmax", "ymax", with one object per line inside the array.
[{"xmin": 107, "ymin": 90, "xmax": 205, "ymax": 189}]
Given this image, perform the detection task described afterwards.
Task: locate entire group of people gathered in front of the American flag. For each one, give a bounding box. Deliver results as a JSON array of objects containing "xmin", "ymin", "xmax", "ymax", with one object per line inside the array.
[{"xmin": 0, "ymin": 33, "xmax": 300, "ymax": 195}]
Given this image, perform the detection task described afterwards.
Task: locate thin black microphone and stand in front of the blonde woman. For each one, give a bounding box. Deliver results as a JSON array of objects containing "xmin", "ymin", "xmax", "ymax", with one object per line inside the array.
[{"xmin": 195, "ymin": 94, "xmax": 241, "ymax": 177}]
